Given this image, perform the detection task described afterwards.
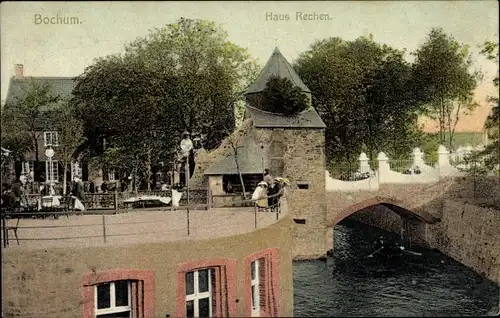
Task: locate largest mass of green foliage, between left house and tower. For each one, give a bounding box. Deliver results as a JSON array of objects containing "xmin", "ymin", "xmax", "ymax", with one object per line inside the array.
[{"xmin": 73, "ymin": 18, "xmax": 258, "ymax": 186}]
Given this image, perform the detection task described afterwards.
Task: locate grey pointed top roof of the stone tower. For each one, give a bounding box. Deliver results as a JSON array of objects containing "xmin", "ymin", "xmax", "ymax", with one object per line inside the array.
[{"xmin": 245, "ymin": 47, "xmax": 311, "ymax": 94}]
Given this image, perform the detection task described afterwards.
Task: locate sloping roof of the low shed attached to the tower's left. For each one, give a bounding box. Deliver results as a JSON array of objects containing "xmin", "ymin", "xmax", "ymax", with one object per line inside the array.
[{"xmin": 204, "ymin": 135, "xmax": 268, "ymax": 175}]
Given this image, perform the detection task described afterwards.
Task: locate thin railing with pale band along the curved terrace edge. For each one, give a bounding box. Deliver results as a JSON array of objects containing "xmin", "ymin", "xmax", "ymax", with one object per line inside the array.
[{"xmin": 1, "ymin": 191, "xmax": 283, "ymax": 247}]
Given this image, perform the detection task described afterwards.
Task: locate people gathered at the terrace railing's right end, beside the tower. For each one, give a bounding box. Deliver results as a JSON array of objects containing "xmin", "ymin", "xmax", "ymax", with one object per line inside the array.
[{"xmin": 252, "ymin": 169, "xmax": 286, "ymax": 210}]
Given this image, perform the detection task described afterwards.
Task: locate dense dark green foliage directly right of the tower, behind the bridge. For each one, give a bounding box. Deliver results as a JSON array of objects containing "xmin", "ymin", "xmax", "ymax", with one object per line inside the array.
[{"xmin": 295, "ymin": 36, "xmax": 428, "ymax": 162}]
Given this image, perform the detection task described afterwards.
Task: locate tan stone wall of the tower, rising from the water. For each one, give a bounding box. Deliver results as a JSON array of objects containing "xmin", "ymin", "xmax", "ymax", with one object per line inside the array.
[{"xmin": 252, "ymin": 129, "xmax": 327, "ymax": 259}]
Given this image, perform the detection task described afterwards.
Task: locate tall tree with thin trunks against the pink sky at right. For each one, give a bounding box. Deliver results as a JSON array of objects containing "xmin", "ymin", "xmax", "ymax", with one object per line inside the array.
[{"xmin": 413, "ymin": 28, "xmax": 481, "ymax": 149}]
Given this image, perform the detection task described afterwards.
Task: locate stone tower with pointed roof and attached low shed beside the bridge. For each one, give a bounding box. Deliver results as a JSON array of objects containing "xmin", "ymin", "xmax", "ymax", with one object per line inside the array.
[{"xmin": 191, "ymin": 48, "xmax": 327, "ymax": 259}]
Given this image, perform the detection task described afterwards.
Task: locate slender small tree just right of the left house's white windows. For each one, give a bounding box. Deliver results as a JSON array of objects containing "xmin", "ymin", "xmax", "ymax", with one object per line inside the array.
[{"xmin": 50, "ymin": 101, "xmax": 85, "ymax": 195}]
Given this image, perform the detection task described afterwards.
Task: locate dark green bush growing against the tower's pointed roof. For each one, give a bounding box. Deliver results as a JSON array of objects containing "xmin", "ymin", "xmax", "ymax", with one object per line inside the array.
[{"xmin": 262, "ymin": 76, "xmax": 307, "ymax": 116}]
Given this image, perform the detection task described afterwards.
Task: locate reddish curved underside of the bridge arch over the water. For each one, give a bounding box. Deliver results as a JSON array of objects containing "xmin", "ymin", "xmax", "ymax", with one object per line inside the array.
[{"xmin": 327, "ymin": 196, "xmax": 439, "ymax": 228}]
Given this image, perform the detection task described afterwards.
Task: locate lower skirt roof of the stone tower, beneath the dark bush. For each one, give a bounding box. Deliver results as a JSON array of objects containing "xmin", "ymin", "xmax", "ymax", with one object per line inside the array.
[{"xmin": 246, "ymin": 104, "xmax": 326, "ymax": 129}]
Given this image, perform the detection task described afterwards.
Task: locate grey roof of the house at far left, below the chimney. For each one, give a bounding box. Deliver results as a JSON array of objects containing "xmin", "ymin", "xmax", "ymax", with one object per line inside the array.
[{"xmin": 5, "ymin": 76, "xmax": 76, "ymax": 107}]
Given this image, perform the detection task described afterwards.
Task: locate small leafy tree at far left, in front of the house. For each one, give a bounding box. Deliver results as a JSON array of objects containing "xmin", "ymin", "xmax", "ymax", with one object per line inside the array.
[{"xmin": 2, "ymin": 80, "xmax": 60, "ymax": 178}]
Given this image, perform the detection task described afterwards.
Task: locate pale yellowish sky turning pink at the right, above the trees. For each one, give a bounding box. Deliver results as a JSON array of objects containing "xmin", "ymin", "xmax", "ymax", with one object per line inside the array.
[{"xmin": 0, "ymin": 0, "xmax": 499, "ymax": 131}]
